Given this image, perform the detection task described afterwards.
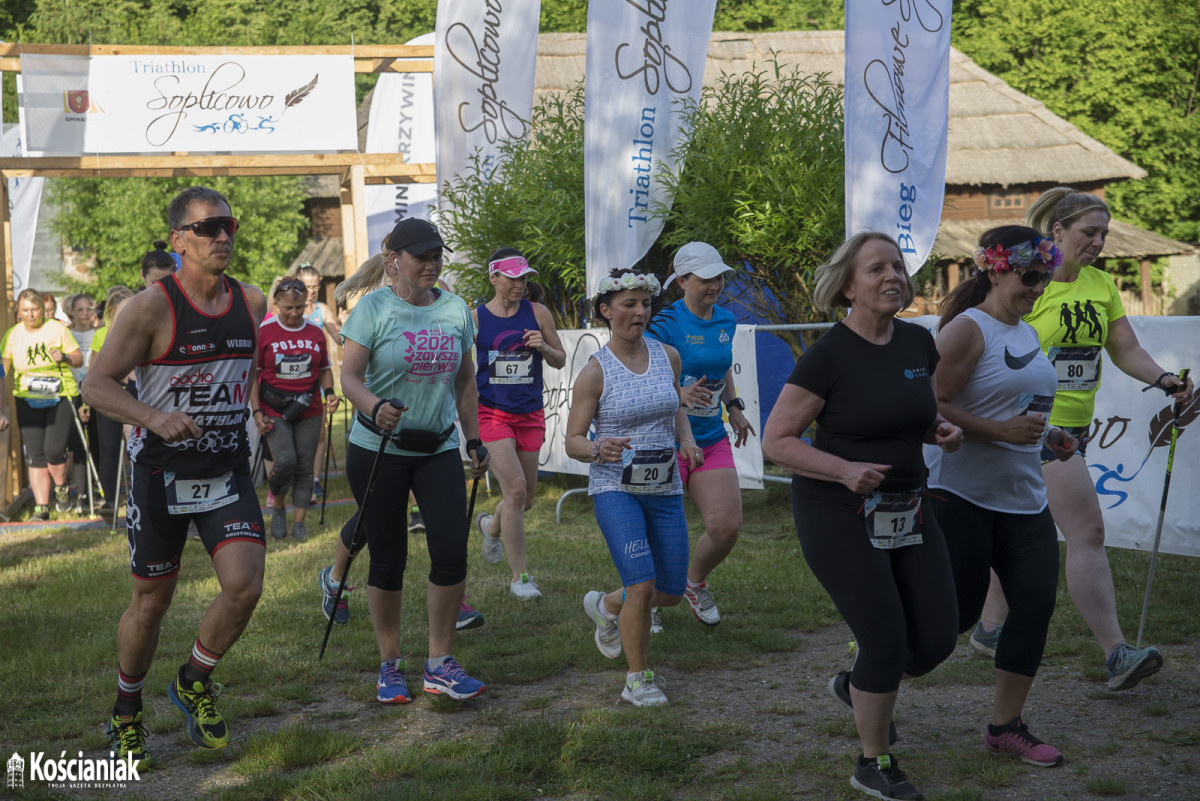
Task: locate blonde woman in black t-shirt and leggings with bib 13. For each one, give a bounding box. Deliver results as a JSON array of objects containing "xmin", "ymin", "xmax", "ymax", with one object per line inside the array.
[{"xmin": 762, "ymin": 233, "xmax": 962, "ymax": 799}]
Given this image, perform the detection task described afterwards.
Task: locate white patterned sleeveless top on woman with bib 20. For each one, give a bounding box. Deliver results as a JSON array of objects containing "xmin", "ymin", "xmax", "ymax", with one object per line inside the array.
[{"xmin": 588, "ymin": 338, "xmax": 683, "ymax": 495}]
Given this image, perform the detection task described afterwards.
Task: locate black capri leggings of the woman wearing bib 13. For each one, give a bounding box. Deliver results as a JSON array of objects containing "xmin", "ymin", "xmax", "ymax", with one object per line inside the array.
[{"xmin": 792, "ymin": 483, "xmax": 959, "ymax": 693}]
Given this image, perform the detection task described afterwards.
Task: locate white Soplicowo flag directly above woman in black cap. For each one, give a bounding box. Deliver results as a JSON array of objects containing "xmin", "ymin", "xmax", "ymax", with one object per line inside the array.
[{"xmin": 433, "ymin": 0, "xmax": 541, "ymax": 186}]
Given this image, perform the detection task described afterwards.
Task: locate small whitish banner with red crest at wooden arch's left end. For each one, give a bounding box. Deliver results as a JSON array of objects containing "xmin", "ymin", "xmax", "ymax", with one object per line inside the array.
[{"xmin": 17, "ymin": 54, "xmax": 89, "ymax": 156}]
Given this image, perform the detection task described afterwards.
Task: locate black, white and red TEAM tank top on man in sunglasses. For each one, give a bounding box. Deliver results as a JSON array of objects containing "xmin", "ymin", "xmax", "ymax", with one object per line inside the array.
[{"xmin": 128, "ymin": 275, "xmax": 256, "ymax": 477}]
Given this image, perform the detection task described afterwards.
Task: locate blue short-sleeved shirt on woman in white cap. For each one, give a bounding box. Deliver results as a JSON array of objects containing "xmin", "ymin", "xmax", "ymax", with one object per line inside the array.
[{"xmin": 646, "ymin": 297, "xmax": 738, "ymax": 448}]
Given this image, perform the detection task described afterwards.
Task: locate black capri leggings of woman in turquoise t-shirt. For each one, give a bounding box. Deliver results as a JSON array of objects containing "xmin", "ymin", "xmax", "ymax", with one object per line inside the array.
[{"xmin": 342, "ymin": 442, "xmax": 467, "ymax": 592}]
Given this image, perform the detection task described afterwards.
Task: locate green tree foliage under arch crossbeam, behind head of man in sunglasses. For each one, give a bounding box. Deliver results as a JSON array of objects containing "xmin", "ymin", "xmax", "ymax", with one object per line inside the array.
[{"xmin": 47, "ymin": 177, "xmax": 308, "ymax": 291}]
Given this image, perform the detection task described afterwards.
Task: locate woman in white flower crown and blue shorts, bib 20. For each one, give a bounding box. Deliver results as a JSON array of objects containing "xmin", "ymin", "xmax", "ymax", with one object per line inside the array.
[{"xmin": 566, "ymin": 270, "xmax": 704, "ymax": 706}]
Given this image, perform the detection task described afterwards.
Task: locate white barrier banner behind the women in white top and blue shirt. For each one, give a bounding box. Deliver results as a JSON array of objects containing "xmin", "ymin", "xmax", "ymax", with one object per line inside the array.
[{"xmin": 538, "ymin": 325, "xmax": 762, "ymax": 489}]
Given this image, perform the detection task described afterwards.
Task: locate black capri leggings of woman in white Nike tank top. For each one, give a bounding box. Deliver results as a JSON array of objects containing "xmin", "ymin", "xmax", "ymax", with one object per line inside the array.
[{"xmin": 934, "ymin": 489, "xmax": 1058, "ymax": 676}]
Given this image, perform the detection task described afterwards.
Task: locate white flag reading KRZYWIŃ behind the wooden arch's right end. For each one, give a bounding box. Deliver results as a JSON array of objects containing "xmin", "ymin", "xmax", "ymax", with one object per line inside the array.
[{"xmin": 366, "ymin": 34, "xmax": 438, "ymax": 253}]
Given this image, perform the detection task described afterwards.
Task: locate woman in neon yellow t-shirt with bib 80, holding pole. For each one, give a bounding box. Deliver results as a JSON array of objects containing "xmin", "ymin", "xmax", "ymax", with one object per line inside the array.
[{"xmin": 971, "ymin": 186, "xmax": 1192, "ymax": 689}]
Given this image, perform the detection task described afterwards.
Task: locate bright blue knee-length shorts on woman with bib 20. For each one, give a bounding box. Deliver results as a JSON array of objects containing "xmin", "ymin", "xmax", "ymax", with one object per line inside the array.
[{"xmin": 592, "ymin": 490, "xmax": 688, "ymax": 596}]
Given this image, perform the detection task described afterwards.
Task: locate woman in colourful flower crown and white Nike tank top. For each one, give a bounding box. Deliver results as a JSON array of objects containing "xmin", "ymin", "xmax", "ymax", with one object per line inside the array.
[{"xmin": 925, "ymin": 225, "xmax": 1078, "ymax": 767}]
